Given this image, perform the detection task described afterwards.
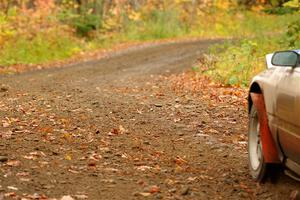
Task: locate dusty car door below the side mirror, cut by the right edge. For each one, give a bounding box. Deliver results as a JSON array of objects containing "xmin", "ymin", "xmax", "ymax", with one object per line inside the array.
[{"xmin": 275, "ymin": 67, "xmax": 300, "ymax": 164}]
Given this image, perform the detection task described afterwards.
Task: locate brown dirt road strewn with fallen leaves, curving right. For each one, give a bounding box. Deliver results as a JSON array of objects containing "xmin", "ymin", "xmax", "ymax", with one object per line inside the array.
[{"xmin": 0, "ymin": 41, "xmax": 300, "ymax": 200}]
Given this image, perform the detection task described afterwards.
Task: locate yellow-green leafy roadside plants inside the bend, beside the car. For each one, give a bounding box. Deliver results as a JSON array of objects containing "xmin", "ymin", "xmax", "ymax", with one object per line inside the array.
[{"xmin": 200, "ymin": 36, "xmax": 286, "ymax": 87}]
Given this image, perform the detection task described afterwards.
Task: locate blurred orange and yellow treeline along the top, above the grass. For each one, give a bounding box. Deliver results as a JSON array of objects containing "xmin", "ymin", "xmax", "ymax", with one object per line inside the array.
[{"xmin": 0, "ymin": 0, "xmax": 294, "ymax": 37}]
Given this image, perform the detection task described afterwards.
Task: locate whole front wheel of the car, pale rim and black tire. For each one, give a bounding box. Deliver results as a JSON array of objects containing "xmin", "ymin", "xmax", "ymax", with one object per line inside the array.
[{"xmin": 248, "ymin": 106, "xmax": 270, "ymax": 182}]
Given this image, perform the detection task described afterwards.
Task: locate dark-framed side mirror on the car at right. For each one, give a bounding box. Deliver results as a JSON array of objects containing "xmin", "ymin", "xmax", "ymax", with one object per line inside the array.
[{"xmin": 271, "ymin": 51, "xmax": 299, "ymax": 67}]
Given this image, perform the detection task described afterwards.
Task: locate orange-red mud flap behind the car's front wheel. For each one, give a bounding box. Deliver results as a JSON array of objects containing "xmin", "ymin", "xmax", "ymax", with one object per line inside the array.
[{"xmin": 250, "ymin": 93, "xmax": 280, "ymax": 163}]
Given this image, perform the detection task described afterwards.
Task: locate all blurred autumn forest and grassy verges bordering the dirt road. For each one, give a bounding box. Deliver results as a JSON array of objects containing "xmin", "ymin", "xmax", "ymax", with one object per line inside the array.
[{"xmin": 0, "ymin": 0, "xmax": 300, "ymax": 86}]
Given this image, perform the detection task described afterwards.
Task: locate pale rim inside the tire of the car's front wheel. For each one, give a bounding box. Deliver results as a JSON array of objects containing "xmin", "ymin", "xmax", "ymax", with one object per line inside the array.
[{"xmin": 249, "ymin": 114, "xmax": 263, "ymax": 170}]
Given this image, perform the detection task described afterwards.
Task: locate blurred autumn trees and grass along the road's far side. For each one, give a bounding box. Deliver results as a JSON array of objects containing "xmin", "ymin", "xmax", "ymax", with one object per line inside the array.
[{"xmin": 0, "ymin": 0, "xmax": 298, "ymax": 74}]
